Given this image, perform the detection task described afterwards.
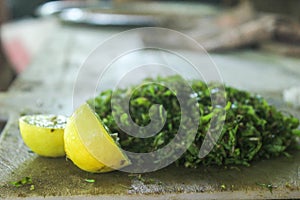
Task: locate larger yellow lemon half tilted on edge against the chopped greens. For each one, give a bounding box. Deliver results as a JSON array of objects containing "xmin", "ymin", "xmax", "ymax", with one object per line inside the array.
[{"xmin": 64, "ymin": 104, "xmax": 131, "ymax": 173}]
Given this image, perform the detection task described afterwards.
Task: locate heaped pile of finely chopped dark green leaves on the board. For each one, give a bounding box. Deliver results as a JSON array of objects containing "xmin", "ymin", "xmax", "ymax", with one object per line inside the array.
[{"xmin": 88, "ymin": 76, "xmax": 300, "ymax": 168}]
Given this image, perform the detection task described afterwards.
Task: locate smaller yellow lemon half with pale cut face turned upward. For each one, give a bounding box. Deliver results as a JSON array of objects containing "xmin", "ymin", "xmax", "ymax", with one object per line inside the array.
[{"xmin": 19, "ymin": 115, "xmax": 67, "ymax": 157}]
